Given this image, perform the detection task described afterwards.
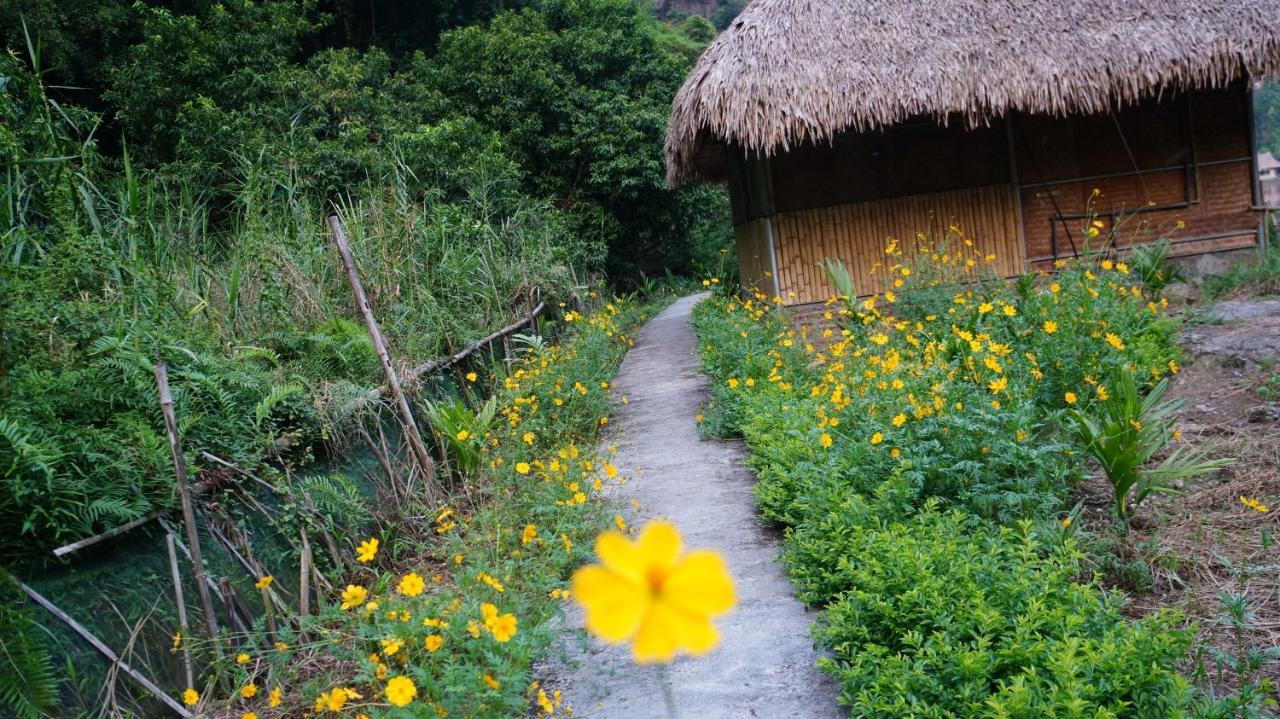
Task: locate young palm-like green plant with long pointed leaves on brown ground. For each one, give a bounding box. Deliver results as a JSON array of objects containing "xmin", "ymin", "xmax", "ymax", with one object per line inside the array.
[{"xmin": 1070, "ymin": 368, "xmax": 1235, "ymax": 521}]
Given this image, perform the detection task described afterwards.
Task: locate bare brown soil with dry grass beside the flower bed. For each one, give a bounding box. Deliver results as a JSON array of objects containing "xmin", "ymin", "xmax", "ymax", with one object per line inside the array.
[{"xmin": 1116, "ymin": 298, "xmax": 1280, "ymax": 691}]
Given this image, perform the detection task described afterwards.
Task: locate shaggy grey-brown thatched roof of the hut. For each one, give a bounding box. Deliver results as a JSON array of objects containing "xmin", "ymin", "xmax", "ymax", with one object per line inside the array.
[{"xmin": 666, "ymin": 0, "xmax": 1280, "ymax": 183}]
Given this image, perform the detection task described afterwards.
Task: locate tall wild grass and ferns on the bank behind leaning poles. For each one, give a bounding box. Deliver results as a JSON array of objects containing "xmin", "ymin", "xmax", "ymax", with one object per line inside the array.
[{"xmin": 0, "ymin": 52, "xmax": 577, "ymax": 555}]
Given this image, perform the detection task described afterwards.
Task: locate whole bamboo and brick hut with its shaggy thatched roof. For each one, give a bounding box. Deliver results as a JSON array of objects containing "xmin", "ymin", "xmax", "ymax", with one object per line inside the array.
[{"xmin": 666, "ymin": 0, "xmax": 1280, "ymax": 304}]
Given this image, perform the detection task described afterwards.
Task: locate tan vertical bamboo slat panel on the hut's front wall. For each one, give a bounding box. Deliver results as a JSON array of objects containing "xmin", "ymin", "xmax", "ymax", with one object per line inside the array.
[{"xmin": 762, "ymin": 184, "xmax": 1027, "ymax": 304}]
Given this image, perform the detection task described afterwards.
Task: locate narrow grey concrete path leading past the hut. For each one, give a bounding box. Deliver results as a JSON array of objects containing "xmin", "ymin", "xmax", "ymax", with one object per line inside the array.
[{"xmin": 549, "ymin": 296, "xmax": 842, "ymax": 719}]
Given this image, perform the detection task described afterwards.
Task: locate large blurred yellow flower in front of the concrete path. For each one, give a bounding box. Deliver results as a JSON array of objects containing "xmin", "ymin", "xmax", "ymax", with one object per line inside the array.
[{"xmin": 573, "ymin": 521, "xmax": 735, "ymax": 664}]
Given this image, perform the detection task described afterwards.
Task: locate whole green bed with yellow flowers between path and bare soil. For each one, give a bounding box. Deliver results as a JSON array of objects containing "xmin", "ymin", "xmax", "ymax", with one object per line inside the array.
[{"xmin": 694, "ymin": 235, "xmax": 1193, "ymax": 718}]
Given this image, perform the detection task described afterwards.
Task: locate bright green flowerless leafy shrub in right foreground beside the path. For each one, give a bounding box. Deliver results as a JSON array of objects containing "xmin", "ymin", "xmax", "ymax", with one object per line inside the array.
[{"xmin": 814, "ymin": 508, "xmax": 1189, "ymax": 719}]
